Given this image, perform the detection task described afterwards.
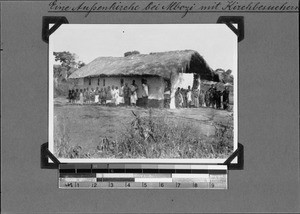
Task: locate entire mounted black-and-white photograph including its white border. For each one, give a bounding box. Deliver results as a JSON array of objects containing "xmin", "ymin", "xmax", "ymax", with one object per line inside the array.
[{"xmin": 48, "ymin": 24, "xmax": 238, "ymax": 164}]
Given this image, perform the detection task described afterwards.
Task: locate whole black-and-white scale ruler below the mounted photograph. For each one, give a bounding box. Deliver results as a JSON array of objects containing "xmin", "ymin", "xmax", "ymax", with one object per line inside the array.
[{"xmin": 59, "ymin": 165, "xmax": 228, "ymax": 189}]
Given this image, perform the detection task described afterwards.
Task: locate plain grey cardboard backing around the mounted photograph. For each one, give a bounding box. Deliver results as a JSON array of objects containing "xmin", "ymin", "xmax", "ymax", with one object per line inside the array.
[{"xmin": 1, "ymin": 2, "xmax": 300, "ymax": 213}]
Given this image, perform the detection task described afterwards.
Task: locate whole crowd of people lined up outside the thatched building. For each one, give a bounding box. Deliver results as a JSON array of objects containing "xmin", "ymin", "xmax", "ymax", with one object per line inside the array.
[{"xmin": 68, "ymin": 79, "xmax": 230, "ymax": 110}]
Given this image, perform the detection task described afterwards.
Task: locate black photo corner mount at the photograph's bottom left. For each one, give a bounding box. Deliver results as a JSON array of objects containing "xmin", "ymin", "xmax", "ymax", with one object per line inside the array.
[{"xmin": 41, "ymin": 142, "xmax": 60, "ymax": 169}]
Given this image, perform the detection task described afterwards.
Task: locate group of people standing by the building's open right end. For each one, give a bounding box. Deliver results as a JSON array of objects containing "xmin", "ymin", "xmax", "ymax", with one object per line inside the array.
[{"xmin": 175, "ymin": 85, "xmax": 229, "ymax": 110}]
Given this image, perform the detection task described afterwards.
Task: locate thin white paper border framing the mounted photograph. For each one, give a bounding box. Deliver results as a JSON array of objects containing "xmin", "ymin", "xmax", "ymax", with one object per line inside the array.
[{"xmin": 48, "ymin": 23, "xmax": 239, "ymax": 165}]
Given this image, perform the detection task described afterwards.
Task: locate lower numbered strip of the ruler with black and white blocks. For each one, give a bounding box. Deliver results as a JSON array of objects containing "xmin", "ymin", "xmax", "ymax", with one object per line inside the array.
[{"xmin": 59, "ymin": 173, "xmax": 227, "ymax": 189}]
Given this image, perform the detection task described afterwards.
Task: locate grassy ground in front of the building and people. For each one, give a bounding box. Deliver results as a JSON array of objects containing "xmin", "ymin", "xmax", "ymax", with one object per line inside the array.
[{"xmin": 54, "ymin": 98, "xmax": 233, "ymax": 159}]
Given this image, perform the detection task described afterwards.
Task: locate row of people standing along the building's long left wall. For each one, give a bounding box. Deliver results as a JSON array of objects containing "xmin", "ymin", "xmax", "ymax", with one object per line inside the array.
[{"xmin": 68, "ymin": 79, "xmax": 148, "ymax": 106}]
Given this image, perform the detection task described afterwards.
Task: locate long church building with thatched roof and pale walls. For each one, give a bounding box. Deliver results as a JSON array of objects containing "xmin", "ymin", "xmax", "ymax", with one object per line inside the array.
[{"xmin": 69, "ymin": 50, "xmax": 216, "ymax": 108}]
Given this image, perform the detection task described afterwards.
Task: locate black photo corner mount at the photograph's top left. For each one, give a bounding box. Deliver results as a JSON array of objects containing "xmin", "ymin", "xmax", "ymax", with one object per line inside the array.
[{"xmin": 42, "ymin": 16, "xmax": 69, "ymax": 43}]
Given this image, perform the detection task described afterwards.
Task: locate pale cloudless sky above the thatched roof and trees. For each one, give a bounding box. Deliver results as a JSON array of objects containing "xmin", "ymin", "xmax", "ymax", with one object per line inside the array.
[{"xmin": 49, "ymin": 24, "xmax": 238, "ymax": 76}]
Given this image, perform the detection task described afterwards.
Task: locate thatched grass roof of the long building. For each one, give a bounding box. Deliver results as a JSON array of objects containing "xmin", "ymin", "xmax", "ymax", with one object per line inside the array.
[{"xmin": 69, "ymin": 50, "xmax": 212, "ymax": 80}]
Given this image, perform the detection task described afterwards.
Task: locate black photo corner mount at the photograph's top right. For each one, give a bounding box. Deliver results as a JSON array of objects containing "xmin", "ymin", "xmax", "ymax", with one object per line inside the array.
[{"xmin": 217, "ymin": 16, "xmax": 244, "ymax": 42}]
